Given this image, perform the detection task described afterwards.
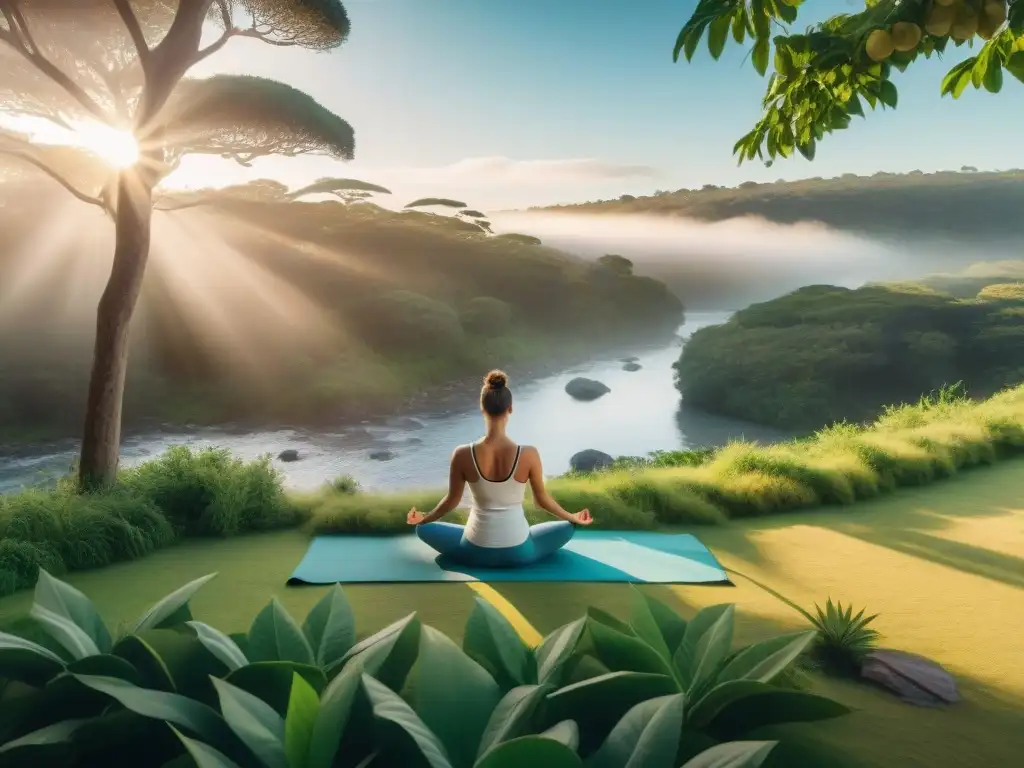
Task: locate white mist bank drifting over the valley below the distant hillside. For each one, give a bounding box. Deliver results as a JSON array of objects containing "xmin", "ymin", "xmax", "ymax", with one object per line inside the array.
[{"xmin": 490, "ymin": 211, "xmax": 1019, "ymax": 310}]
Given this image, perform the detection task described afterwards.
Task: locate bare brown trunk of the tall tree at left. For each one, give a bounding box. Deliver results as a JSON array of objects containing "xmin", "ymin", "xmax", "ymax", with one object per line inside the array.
[{"xmin": 79, "ymin": 171, "xmax": 153, "ymax": 490}]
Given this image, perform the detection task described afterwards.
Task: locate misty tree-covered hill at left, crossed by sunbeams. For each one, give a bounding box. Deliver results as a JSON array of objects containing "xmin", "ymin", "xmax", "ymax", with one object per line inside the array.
[{"xmin": 0, "ymin": 185, "xmax": 682, "ymax": 444}]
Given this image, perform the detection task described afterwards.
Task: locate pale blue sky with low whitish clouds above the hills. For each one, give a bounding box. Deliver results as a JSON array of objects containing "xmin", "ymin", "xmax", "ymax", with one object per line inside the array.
[{"xmin": 176, "ymin": 0, "xmax": 1022, "ymax": 209}]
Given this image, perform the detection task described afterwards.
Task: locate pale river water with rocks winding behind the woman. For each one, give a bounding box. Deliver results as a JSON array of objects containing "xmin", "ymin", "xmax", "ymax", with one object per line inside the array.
[{"xmin": 0, "ymin": 312, "xmax": 784, "ymax": 493}]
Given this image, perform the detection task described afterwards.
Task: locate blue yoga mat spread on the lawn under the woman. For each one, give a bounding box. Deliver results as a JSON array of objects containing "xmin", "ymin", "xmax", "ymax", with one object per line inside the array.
[{"xmin": 288, "ymin": 530, "xmax": 730, "ymax": 585}]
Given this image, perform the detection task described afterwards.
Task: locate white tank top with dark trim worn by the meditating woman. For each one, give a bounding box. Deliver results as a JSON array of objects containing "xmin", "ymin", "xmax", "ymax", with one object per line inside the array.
[{"xmin": 466, "ymin": 444, "xmax": 529, "ymax": 548}]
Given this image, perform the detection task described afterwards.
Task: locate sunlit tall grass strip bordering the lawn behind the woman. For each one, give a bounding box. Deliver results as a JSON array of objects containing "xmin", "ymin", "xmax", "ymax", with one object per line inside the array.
[{"xmin": 304, "ymin": 385, "xmax": 1024, "ymax": 534}]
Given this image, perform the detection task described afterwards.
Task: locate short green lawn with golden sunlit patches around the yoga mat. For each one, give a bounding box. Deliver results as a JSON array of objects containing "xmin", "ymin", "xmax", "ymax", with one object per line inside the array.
[{"xmin": 0, "ymin": 460, "xmax": 1024, "ymax": 768}]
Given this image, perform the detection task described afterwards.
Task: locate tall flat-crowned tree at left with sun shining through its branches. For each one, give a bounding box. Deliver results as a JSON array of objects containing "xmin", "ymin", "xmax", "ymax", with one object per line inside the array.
[{"xmin": 0, "ymin": 0, "xmax": 354, "ymax": 488}]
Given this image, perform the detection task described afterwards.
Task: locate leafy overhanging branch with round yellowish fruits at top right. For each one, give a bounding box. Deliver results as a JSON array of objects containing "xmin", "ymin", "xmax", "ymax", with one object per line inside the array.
[{"xmin": 673, "ymin": 0, "xmax": 1024, "ymax": 165}]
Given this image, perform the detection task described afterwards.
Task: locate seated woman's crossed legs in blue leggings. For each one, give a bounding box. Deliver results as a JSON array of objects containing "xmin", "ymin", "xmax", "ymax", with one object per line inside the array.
[{"xmin": 416, "ymin": 520, "xmax": 575, "ymax": 568}]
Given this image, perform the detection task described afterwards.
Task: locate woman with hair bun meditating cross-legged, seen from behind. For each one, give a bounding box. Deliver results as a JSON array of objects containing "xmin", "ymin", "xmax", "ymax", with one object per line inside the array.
[{"xmin": 407, "ymin": 371, "xmax": 593, "ymax": 568}]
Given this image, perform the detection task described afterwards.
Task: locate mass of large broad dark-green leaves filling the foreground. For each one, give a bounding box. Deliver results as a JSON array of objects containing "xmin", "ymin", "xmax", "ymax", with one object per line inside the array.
[{"xmin": 0, "ymin": 570, "xmax": 848, "ymax": 768}]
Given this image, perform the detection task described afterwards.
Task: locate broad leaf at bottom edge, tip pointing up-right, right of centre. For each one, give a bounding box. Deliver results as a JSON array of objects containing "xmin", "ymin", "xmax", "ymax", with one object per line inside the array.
[{"xmin": 587, "ymin": 693, "xmax": 685, "ymax": 768}]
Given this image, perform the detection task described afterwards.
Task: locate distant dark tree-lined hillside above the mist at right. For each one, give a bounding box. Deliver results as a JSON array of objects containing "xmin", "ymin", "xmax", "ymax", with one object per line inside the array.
[{"xmin": 543, "ymin": 169, "xmax": 1024, "ymax": 239}]
